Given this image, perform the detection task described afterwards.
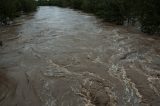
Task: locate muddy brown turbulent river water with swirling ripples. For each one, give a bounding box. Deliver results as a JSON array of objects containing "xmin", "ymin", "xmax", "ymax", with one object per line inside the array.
[{"xmin": 0, "ymin": 7, "xmax": 160, "ymax": 106}]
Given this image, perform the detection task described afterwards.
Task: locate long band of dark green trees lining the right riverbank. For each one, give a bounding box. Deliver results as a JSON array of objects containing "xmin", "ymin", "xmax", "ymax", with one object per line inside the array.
[{"xmin": 38, "ymin": 0, "xmax": 160, "ymax": 34}]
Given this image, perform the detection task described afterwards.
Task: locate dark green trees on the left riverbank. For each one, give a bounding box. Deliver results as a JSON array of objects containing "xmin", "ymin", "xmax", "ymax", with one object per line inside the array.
[{"xmin": 0, "ymin": 0, "xmax": 37, "ymax": 24}]
